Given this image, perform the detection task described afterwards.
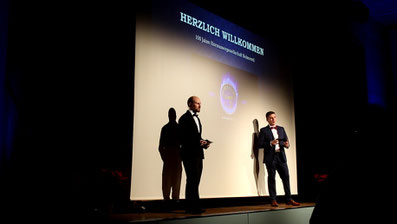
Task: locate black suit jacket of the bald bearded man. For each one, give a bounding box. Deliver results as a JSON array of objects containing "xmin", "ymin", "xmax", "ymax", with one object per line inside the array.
[{"xmin": 178, "ymin": 111, "xmax": 204, "ymax": 160}]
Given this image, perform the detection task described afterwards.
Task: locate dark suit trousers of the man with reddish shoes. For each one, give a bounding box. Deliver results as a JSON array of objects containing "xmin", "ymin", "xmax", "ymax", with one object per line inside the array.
[{"xmin": 265, "ymin": 153, "xmax": 291, "ymax": 201}]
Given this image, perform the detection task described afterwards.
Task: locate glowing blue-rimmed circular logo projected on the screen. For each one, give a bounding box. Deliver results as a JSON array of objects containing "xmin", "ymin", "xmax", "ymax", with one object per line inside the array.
[{"xmin": 219, "ymin": 74, "xmax": 238, "ymax": 114}]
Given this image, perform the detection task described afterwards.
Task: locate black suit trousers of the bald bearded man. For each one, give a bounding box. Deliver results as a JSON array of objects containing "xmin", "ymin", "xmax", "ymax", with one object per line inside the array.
[{"xmin": 183, "ymin": 158, "xmax": 203, "ymax": 210}]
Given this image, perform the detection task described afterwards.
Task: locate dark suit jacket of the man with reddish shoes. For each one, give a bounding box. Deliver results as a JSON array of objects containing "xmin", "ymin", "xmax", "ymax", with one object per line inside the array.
[{"xmin": 259, "ymin": 125, "xmax": 288, "ymax": 163}]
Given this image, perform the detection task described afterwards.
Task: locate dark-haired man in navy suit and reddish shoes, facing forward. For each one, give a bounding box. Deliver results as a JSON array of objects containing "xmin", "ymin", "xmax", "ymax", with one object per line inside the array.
[{"xmin": 259, "ymin": 111, "xmax": 300, "ymax": 207}]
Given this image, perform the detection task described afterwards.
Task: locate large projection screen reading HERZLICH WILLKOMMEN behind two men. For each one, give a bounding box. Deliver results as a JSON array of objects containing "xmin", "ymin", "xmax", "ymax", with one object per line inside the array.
[{"xmin": 130, "ymin": 1, "xmax": 297, "ymax": 200}]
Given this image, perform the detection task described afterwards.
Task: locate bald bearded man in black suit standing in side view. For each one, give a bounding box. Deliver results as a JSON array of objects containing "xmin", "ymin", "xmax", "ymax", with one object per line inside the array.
[{"xmin": 178, "ymin": 96, "xmax": 209, "ymax": 214}]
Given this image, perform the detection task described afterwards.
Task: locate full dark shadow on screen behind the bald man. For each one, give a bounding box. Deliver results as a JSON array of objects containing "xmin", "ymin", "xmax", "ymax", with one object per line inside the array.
[{"xmin": 159, "ymin": 107, "xmax": 182, "ymax": 200}]
